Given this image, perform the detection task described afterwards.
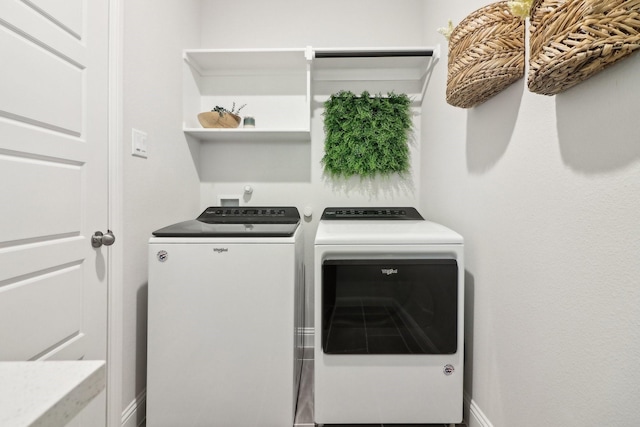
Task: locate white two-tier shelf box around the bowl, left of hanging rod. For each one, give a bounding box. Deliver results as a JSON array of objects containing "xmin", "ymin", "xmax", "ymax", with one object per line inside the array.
[{"xmin": 183, "ymin": 48, "xmax": 312, "ymax": 136}]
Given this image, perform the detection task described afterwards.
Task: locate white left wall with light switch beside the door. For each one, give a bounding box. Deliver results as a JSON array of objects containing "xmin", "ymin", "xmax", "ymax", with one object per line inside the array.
[{"xmin": 119, "ymin": 0, "xmax": 200, "ymax": 426}]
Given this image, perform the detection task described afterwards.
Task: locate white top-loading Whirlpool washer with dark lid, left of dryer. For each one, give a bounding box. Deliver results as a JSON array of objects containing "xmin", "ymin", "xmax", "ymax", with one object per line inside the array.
[{"xmin": 147, "ymin": 207, "xmax": 304, "ymax": 427}]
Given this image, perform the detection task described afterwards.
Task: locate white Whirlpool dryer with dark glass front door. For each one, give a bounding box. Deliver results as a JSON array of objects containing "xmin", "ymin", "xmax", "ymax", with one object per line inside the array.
[{"xmin": 314, "ymin": 208, "xmax": 464, "ymax": 424}]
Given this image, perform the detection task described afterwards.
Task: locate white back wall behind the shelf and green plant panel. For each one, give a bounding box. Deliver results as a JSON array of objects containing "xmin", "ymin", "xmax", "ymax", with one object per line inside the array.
[{"xmin": 200, "ymin": 0, "xmax": 424, "ymax": 338}]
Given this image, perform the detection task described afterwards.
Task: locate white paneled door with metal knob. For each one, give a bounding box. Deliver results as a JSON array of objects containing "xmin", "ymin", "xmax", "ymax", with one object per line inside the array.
[{"xmin": 0, "ymin": 0, "xmax": 109, "ymax": 426}]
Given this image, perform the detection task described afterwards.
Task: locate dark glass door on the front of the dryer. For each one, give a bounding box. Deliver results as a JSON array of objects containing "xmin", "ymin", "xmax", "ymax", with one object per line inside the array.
[{"xmin": 322, "ymin": 259, "xmax": 458, "ymax": 354}]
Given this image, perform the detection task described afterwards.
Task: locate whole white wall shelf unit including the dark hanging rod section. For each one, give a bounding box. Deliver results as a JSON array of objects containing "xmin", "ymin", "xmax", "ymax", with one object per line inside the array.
[{"xmin": 183, "ymin": 46, "xmax": 440, "ymax": 142}]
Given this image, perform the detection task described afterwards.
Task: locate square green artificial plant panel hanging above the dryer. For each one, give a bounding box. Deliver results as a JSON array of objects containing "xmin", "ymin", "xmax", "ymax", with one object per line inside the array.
[{"xmin": 322, "ymin": 91, "xmax": 412, "ymax": 177}]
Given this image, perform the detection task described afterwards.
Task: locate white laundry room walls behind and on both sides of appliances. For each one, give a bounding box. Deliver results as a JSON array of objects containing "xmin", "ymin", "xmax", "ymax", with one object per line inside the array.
[{"xmin": 123, "ymin": 0, "xmax": 640, "ymax": 427}]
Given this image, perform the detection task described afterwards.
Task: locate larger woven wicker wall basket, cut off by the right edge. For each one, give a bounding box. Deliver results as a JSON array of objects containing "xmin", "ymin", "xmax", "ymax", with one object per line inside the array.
[{"xmin": 527, "ymin": 0, "xmax": 640, "ymax": 95}]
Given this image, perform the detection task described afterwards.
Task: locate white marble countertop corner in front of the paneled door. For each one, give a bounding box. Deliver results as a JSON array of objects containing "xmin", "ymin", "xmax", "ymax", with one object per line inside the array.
[{"xmin": 0, "ymin": 360, "xmax": 106, "ymax": 427}]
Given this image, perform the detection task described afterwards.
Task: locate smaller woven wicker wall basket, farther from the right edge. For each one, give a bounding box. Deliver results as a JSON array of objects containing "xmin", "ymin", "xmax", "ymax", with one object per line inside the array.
[{"xmin": 447, "ymin": 1, "xmax": 525, "ymax": 108}]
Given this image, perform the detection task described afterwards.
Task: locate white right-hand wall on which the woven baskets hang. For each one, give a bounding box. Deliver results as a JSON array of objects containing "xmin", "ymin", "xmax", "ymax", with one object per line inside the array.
[{"xmin": 420, "ymin": 0, "xmax": 640, "ymax": 427}]
